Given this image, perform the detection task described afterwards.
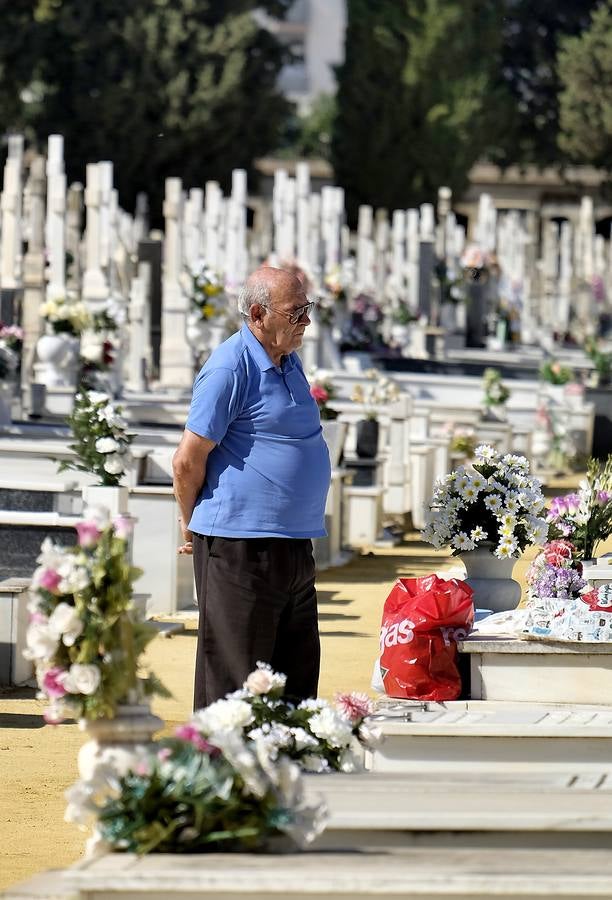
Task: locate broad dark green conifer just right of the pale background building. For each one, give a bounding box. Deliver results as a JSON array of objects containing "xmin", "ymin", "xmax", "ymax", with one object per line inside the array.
[{"xmin": 332, "ymin": 0, "xmax": 507, "ymax": 218}]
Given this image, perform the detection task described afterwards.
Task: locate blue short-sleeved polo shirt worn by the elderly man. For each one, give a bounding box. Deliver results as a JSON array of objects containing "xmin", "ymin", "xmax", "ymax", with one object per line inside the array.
[{"xmin": 186, "ymin": 325, "xmax": 331, "ymax": 538}]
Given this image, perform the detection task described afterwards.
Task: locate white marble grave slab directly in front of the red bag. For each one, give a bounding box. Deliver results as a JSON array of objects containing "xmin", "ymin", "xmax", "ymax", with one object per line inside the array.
[{"xmin": 366, "ymin": 699, "xmax": 612, "ymax": 778}]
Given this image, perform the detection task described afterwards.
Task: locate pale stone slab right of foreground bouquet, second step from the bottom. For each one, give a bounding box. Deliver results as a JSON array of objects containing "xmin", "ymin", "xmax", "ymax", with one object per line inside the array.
[{"xmin": 306, "ymin": 767, "xmax": 612, "ymax": 850}]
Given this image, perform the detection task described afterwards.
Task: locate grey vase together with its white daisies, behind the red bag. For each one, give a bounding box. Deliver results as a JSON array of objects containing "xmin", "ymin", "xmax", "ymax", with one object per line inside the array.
[{"xmin": 422, "ymin": 444, "xmax": 548, "ymax": 611}]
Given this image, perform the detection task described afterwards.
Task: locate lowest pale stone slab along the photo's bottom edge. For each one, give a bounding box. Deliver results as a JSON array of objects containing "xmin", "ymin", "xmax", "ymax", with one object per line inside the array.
[{"xmin": 3, "ymin": 847, "xmax": 612, "ymax": 900}]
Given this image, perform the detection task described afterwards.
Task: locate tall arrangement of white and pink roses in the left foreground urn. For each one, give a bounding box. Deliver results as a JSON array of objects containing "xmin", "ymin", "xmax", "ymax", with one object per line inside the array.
[{"xmin": 24, "ymin": 507, "xmax": 168, "ymax": 724}]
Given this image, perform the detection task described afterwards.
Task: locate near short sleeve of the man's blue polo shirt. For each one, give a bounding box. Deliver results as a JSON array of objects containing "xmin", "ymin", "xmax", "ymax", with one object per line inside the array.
[{"xmin": 186, "ymin": 368, "xmax": 242, "ymax": 444}]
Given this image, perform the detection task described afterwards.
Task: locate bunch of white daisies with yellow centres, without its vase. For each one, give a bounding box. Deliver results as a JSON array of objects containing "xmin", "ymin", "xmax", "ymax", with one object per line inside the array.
[{"xmin": 422, "ymin": 444, "xmax": 548, "ymax": 559}]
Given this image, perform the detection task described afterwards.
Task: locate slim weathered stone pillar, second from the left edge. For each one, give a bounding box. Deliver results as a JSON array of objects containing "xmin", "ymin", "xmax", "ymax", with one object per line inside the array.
[{"xmin": 21, "ymin": 156, "xmax": 45, "ymax": 413}]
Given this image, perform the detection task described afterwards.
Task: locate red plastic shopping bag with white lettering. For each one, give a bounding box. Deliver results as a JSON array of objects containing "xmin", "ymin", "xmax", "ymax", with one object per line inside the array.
[{"xmin": 380, "ymin": 575, "xmax": 474, "ymax": 700}]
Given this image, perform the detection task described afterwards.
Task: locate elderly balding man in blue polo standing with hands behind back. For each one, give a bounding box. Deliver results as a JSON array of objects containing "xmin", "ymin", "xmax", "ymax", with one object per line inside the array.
[{"xmin": 173, "ymin": 268, "xmax": 330, "ymax": 709}]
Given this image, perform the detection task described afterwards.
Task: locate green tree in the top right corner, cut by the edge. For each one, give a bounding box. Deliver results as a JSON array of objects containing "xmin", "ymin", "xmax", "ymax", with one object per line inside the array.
[{"xmin": 559, "ymin": 0, "xmax": 612, "ymax": 169}]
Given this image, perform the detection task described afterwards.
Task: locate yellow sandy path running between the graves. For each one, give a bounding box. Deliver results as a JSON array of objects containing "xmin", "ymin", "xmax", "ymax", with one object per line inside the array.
[{"xmin": 0, "ymin": 520, "xmax": 612, "ymax": 890}]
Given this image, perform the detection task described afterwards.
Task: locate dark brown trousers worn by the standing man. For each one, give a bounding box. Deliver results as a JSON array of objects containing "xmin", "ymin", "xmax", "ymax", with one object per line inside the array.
[{"xmin": 193, "ymin": 534, "xmax": 320, "ymax": 709}]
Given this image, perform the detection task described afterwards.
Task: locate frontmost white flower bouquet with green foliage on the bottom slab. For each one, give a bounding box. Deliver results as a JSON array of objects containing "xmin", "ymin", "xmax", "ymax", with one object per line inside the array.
[{"xmin": 65, "ymin": 700, "xmax": 327, "ymax": 855}]
